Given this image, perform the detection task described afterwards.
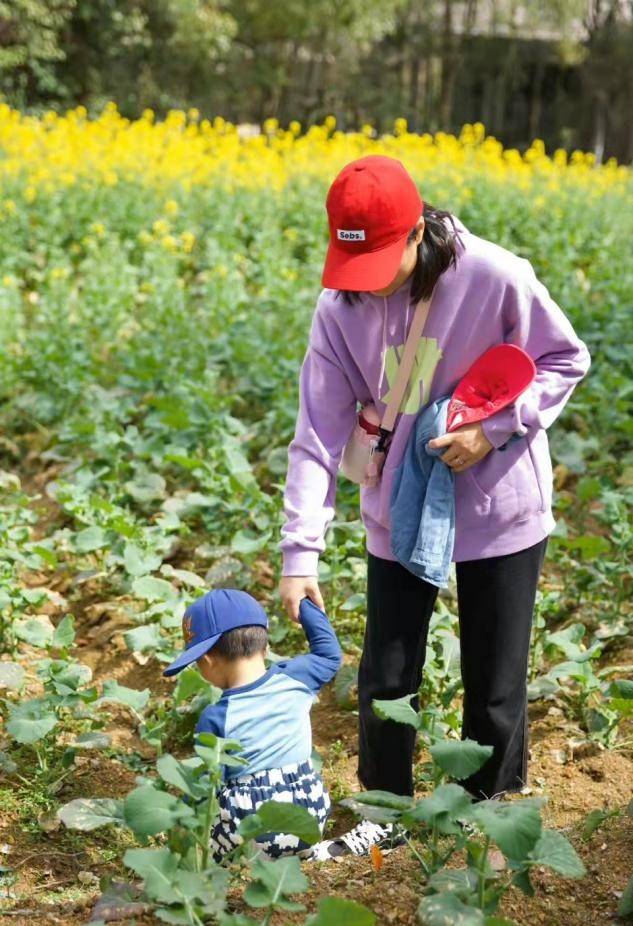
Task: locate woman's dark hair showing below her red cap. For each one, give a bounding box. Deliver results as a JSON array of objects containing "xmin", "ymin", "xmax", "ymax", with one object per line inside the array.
[{"xmin": 338, "ymin": 203, "xmax": 457, "ymax": 305}]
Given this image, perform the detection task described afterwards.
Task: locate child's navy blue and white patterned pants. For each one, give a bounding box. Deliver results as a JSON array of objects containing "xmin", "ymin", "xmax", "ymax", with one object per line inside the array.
[{"xmin": 211, "ymin": 760, "xmax": 330, "ymax": 862}]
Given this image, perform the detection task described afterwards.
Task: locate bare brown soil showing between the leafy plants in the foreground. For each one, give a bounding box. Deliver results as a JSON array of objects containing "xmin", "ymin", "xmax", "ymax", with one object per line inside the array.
[{"xmin": 0, "ymin": 490, "xmax": 633, "ymax": 926}]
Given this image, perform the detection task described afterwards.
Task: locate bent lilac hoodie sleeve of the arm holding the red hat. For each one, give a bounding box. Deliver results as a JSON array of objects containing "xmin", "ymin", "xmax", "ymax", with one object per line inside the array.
[{"xmin": 482, "ymin": 261, "xmax": 590, "ymax": 449}]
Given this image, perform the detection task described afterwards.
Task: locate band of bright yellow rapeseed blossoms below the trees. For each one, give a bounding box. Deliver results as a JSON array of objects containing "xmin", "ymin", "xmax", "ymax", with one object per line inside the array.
[{"xmin": 0, "ymin": 104, "xmax": 630, "ymax": 201}]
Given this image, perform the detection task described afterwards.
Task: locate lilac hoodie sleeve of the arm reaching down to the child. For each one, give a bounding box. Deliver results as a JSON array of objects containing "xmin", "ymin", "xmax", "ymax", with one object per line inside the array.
[{"xmin": 279, "ymin": 305, "xmax": 356, "ymax": 576}]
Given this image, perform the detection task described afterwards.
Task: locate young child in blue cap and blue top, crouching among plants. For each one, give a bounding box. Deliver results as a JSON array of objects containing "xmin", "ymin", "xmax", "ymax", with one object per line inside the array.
[{"xmin": 163, "ymin": 589, "xmax": 341, "ymax": 861}]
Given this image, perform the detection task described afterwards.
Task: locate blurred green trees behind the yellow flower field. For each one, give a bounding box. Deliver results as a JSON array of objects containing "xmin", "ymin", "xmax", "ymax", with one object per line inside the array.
[{"xmin": 0, "ymin": 0, "xmax": 633, "ymax": 161}]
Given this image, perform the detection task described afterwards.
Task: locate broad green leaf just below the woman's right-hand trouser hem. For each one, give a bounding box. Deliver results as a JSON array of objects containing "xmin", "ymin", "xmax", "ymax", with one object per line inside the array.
[{"xmin": 471, "ymin": 799, "xmax": 542, "ymax": 860}]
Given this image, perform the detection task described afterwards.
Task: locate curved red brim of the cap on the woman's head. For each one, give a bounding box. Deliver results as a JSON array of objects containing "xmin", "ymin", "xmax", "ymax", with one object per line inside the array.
[{"xmin": 321, "ymin": 232, "xmax": 409, "ymax": 292}]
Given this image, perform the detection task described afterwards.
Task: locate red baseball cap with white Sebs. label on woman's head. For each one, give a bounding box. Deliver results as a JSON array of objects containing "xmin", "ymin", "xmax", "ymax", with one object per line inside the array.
[{"xmin": 322, "ymin": 154, "xmax": 424, "ymax": 292}]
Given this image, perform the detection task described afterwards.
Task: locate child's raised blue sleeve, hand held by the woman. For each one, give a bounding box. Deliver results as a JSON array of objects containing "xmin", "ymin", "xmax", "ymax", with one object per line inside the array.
[{"xmin": 277, "ymin": 598, "xmax": 342, "ymax": 694}]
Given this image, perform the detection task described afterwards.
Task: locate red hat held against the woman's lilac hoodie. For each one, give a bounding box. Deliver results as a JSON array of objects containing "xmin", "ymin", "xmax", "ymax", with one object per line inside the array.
[{"xmin": 446, "ymin": 344, "xmax": 536, "ymax": 432}]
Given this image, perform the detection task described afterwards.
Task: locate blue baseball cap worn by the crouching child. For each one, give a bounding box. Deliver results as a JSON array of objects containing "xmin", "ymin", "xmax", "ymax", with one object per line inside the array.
[{"xmin": 163, "ymin": 588, "xmax": 268, "ymax": 675}]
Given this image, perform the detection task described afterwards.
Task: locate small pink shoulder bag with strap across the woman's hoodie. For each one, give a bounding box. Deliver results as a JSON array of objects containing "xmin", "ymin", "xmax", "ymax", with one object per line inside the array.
[{"xmin": 340, "ymin": 300, "xmax": 431, "ymax": 487}]
